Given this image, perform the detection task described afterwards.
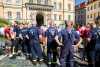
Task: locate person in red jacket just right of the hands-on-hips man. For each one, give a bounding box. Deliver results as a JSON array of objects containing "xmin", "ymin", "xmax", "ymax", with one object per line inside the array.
[{"xmin": 78, "ymin": 24, "xmax": 91, "ymax": 61}]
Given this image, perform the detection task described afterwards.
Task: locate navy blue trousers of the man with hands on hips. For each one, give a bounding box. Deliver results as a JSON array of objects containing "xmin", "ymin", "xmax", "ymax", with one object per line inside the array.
[{"xmin": 60, "ymin": 46, "xmax": 74, "ymax": 67}]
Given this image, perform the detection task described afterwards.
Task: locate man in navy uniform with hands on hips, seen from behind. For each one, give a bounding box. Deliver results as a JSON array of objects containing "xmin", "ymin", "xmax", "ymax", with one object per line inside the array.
[{"xmin": 56, "ymin": 21, "xmax": 80, "ymax": 67}]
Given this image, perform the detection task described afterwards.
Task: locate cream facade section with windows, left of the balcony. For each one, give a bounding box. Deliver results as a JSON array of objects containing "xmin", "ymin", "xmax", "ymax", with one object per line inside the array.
[{"xmin": 2, "ymin": 0, "xmax": 26, "ymax": 22}]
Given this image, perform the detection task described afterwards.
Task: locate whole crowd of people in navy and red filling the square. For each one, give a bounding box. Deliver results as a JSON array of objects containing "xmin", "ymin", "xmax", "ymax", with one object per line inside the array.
[{"xmin": 1, "ymin": 20, "xmax": 100, "ymax": 67}]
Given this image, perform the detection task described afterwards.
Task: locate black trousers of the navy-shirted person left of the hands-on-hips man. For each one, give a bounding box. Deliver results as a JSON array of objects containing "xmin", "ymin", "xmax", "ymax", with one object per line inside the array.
[{"xmin": 47, "ymin": 40, "xmax": 58, "ymax": 67}]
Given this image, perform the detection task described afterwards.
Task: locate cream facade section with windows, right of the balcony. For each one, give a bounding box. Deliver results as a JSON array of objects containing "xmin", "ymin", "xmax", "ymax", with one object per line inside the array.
[{"xmin": 52, "ymin": 0, "xmax": 75, "ymax": 25}]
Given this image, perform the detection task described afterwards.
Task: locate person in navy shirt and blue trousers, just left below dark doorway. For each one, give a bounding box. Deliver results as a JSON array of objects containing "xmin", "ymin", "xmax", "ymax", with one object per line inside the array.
[{"xmin": 28, "ymin": 24, "xmax": 43, "ymax": 62}]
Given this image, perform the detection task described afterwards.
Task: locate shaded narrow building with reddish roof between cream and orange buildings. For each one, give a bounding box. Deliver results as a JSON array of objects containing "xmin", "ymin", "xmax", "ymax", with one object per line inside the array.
[{"xmin": 75, "ymin": 2, "xmax": 86, "ymax": 25}]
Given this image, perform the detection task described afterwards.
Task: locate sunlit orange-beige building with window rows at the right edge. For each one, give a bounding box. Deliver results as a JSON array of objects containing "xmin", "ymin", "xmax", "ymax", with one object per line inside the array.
[{"xmin": 86, "ymin": 0, "xmax": 100, "ymax": 23}]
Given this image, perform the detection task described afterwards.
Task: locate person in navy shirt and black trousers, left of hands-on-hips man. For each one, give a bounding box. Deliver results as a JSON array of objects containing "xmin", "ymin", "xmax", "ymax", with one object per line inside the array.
[{"xmin": 45, "ymin": 21, "xmax": 58, "ymax": 67}]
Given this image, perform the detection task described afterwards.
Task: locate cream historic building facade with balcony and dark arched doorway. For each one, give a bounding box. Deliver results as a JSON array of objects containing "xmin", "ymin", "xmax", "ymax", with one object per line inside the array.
[{"xmin": 0, "ymin": 0, "xmax": 75, "ymax": 25}]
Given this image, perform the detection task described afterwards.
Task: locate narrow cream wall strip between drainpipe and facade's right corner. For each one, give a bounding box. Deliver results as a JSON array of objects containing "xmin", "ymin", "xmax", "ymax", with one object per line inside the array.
[{"xmin": 64, "ymin": 0, "xmax": 75, "ymax": 21}]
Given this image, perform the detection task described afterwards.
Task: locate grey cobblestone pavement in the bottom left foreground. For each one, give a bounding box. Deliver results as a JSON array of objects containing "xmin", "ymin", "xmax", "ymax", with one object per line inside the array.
[{"xmin": 0, "ymin": 57, "xmax": 47, "ymax": 67}]
